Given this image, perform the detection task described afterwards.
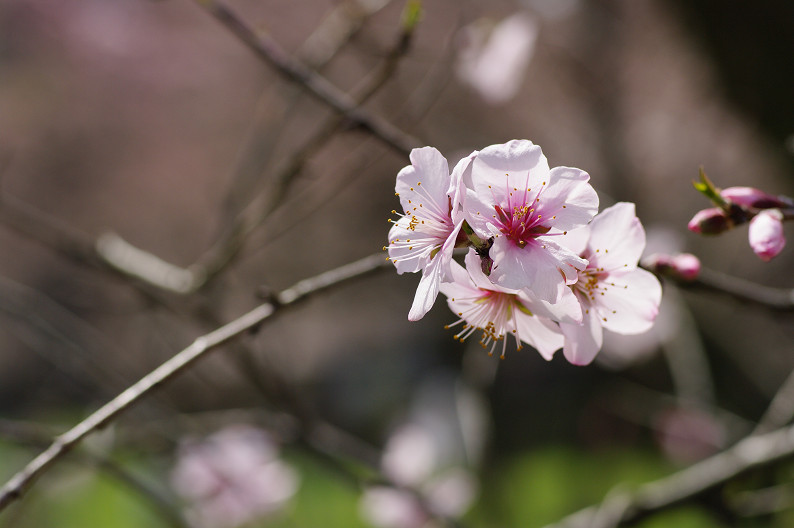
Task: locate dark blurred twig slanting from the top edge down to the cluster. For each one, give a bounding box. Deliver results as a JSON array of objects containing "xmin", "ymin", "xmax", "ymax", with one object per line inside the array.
[{"xmin": 196, "ymin": 0, "xmax": 420, "ymax": 156}]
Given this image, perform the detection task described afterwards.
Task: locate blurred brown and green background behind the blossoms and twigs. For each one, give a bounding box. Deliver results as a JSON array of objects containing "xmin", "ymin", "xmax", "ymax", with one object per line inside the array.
[{"xmin": 0, "ymin": 0, "xmax": 794, "ymax": 528}]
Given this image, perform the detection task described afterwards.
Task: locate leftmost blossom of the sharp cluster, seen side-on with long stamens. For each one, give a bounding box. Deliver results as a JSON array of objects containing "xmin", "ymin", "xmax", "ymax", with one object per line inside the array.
[{"xmin": 388, "ymin": 147, "xmax": 463, "ymax": 321}]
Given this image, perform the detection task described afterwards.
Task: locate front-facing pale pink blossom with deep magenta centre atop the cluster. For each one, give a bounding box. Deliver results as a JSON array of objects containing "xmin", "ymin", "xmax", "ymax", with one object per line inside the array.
[{"xmin": 462, "ymin": 140, "xmax": 598, "ymax": 303}]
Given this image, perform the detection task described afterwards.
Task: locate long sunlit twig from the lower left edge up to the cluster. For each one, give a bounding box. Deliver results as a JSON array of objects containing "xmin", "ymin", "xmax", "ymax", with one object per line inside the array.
[{"xmin": 0, "ymin": 253, "xmax": 388, "ymax": 511}]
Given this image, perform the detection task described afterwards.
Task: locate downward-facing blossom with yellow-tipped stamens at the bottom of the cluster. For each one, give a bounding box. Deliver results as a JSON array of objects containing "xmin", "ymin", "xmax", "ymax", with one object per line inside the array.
[{"xmin": 441, "ymin": 249, "xmax": 581, "ymax": 359}]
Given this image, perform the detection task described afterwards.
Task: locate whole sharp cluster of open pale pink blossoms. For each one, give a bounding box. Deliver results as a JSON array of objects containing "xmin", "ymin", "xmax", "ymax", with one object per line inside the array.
[{"xmin": 384, "ymin": 140, "xmax": 661, "ymax": 365}]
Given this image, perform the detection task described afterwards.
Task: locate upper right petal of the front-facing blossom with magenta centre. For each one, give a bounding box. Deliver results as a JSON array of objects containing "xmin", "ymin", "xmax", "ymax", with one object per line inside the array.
[{"xmin": 538, "ymin": 167, "xmax": 598, "ymax": 231}]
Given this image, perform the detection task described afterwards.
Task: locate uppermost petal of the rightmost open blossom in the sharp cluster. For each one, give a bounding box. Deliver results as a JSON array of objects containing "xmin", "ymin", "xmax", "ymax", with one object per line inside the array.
[{"xmin": 588, "ymin": 202, "xmax": 645, "ymax": 270}]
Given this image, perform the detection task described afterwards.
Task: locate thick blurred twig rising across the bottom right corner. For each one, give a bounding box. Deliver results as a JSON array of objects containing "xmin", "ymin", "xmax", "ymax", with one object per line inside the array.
[{"xmin": 546, "ymin": 420, "xmax": 794, "ymax": 528}]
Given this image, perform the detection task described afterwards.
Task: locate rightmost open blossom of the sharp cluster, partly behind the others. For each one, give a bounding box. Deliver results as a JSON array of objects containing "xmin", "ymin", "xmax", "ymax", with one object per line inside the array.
[{"xmin": 560, "ymin": 202, "xmax": 662, "ymax": 365}]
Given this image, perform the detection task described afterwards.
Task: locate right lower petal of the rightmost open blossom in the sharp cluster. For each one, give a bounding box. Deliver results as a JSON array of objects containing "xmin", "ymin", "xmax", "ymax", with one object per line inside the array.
[{"xmin": 594, "ymin": 268, "xmax": 662, "ymax": 334}]
